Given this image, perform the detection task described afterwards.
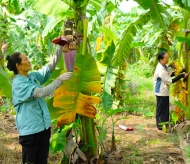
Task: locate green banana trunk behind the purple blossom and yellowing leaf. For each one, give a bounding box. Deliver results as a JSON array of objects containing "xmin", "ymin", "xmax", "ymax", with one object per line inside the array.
[{"xmin": 75, "ymin": 6, "xmax": 97, "ymax": 160}]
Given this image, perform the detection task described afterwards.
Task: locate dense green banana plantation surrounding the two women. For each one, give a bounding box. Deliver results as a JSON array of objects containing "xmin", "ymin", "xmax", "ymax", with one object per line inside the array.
[{"xmin": 0, "ymin": 0, "xmax": 190, "ymax": 164}]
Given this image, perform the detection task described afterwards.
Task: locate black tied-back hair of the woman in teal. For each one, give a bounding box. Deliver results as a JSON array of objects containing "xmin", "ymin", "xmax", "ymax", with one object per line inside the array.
[{"xmin": 6, "ymin": 52, "xmax": 22, "ymax": 75}]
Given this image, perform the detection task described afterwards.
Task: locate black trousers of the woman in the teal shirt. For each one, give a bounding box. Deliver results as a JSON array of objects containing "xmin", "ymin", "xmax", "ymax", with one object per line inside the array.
[{"xmin": 19, "ymin": 128, "xmax": 51, "ymax": 164}]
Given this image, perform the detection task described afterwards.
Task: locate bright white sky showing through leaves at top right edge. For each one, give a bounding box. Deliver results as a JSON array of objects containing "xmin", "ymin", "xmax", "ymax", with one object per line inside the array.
[{"xmin": 119, "ymin": 0, "xmax": 173, "ymax": 12}]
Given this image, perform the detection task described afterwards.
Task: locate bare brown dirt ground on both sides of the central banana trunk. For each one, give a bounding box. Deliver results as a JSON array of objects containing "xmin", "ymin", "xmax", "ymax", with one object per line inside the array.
[{"xmin": 0, "ymin": 114, "xmax": 185, "ymax": 164}]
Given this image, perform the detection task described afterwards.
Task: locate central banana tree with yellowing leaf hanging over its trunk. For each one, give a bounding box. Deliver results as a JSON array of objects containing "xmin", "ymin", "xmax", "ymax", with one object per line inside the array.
[{"xmin": 24, "ymin": 0, "xmax": 107, "ymax": 161}]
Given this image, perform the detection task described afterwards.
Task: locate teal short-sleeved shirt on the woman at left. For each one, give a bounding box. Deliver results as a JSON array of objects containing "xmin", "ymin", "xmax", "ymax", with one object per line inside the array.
[{"xmin": 12, "ymin": 66, "xmax": 51, "ymax": 136}]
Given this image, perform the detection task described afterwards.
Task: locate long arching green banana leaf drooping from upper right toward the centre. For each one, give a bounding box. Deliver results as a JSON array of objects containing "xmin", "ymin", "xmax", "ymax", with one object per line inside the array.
[{"xmin": 112, "ymin": 0, "xmax": 174, "ymax": 66}]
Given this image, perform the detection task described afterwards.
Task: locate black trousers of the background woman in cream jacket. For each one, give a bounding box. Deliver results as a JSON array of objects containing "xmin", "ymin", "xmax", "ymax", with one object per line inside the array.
[{"xmin": 156, "ymin": 96, "xmax": 169, "ymax": 130}]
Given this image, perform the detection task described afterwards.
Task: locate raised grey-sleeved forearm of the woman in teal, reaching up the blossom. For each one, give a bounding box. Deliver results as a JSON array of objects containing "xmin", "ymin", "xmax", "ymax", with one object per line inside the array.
[{"xmin": 46, "ymin": 45, "xmax": 62, "ymax": 72}]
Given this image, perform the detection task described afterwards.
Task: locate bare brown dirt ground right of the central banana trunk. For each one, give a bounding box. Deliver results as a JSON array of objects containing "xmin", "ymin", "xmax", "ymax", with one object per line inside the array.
[{"xmin": 104, "ymin": 115, "xmax": 185, "ymax": 164}]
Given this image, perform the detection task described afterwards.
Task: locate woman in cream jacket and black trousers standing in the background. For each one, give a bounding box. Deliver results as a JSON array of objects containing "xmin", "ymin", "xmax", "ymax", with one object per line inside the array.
[{"xmin": 154, "ymin": 51, "xmax": 188, "ymax": 130}]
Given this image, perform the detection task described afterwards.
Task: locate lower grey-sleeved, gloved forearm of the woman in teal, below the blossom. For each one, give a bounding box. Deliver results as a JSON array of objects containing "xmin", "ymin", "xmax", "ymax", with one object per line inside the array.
[{"xmin": 33, "ymin": 72, "xmax": 72, "ymax": 98}]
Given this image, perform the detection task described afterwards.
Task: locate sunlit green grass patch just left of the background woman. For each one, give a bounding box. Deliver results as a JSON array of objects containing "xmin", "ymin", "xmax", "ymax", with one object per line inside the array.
[{"xmin": 125, "ymin": 63, "xmax": 156, "ymax": 116}]
